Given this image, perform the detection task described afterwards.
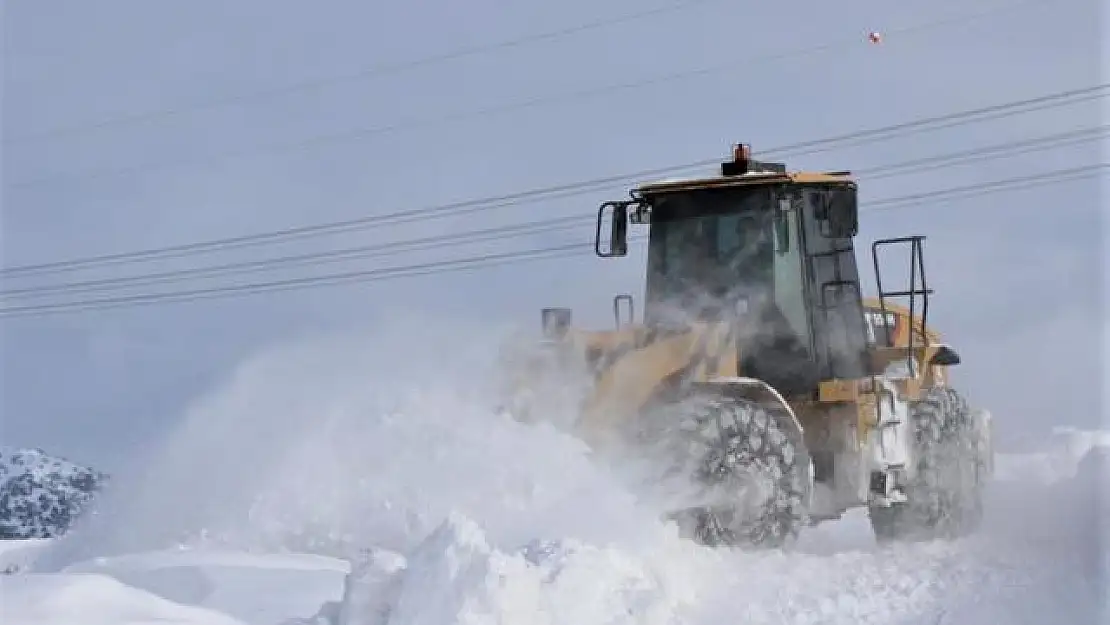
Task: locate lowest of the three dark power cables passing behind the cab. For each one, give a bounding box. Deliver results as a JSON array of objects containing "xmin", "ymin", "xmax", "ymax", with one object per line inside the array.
[{"xmin": 0, "ymin": 163, "xmax": 1110, "ymax": 317}]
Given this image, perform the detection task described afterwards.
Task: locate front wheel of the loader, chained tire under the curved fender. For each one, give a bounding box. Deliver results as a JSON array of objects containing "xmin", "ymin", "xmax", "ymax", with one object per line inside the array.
[{"xmin": 630, "ymin": 392, "xmax": 809, "ymax": 548}]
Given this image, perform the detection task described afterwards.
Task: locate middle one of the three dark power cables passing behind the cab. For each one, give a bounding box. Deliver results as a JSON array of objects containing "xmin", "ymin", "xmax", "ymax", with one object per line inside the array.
[{"xmin": 0, "ymin": 125, "xmax": 1110, "ymax": 300}]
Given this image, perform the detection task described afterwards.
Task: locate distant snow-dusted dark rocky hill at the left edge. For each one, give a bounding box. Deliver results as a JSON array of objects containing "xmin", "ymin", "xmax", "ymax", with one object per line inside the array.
[{"xmin": 0, "ymin": 447, "xmax": 108, "ymax": 540}]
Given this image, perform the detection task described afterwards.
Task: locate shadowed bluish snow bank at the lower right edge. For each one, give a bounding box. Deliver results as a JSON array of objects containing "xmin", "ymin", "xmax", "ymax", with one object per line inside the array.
[{"xmin": 967, "ymin": 429, "xmax": 1110, "ymax": 625}]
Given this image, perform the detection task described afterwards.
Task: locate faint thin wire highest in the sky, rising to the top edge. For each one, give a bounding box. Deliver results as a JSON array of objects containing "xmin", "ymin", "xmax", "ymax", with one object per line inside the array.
[{"xmin": 2, "ymin": 0, "xmax": 728, "ymax": 144}]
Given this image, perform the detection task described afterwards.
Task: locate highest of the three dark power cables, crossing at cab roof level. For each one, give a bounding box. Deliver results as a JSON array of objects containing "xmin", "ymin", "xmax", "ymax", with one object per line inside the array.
[{"xmin": 0, "ymin": 83, "xmax": 1110, "ymax": 278}]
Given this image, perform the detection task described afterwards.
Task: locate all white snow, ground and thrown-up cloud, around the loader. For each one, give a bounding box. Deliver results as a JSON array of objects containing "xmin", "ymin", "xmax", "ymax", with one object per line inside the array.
[{"xmin": 0, "ymin": 319, "xmax": 1110, "ymax": 625}]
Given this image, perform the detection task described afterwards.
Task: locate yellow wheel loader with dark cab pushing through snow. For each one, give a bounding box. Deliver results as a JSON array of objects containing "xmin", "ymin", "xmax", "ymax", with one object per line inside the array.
[{"xmin": 505, "ymin": 144, "xmax": 993, "ymax": 548}]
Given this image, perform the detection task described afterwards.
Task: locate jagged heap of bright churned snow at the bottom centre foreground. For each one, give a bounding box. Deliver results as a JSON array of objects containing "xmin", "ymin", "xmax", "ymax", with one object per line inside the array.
[{"xmin": 355, "ymin": 514, "xmax": 699, "ymax": 625}]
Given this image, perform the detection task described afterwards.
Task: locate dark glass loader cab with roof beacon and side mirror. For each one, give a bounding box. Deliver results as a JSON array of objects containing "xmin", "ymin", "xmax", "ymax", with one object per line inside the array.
[{"xmin": 597, "ymin": 146, "xmax": 868, "ymax": 394}]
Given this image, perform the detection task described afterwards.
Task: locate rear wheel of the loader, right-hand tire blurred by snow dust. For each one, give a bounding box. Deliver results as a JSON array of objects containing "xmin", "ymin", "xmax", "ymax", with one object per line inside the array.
[{"xmin": 869, "ymin": 387, "xmax": 989, "ymax": 543}]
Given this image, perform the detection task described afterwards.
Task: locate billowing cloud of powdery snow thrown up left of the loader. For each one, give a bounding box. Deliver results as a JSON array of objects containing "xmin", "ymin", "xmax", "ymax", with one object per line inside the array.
[{"xmin": 32, "ymin": 314, "xmax": 692, "ymax": 564}]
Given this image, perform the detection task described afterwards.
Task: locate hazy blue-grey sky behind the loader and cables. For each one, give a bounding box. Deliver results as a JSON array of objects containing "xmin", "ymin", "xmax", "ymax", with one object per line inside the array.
[{"xmin": 0, "ymin": 0, "xmax": 1107, "ymax": 467}]
